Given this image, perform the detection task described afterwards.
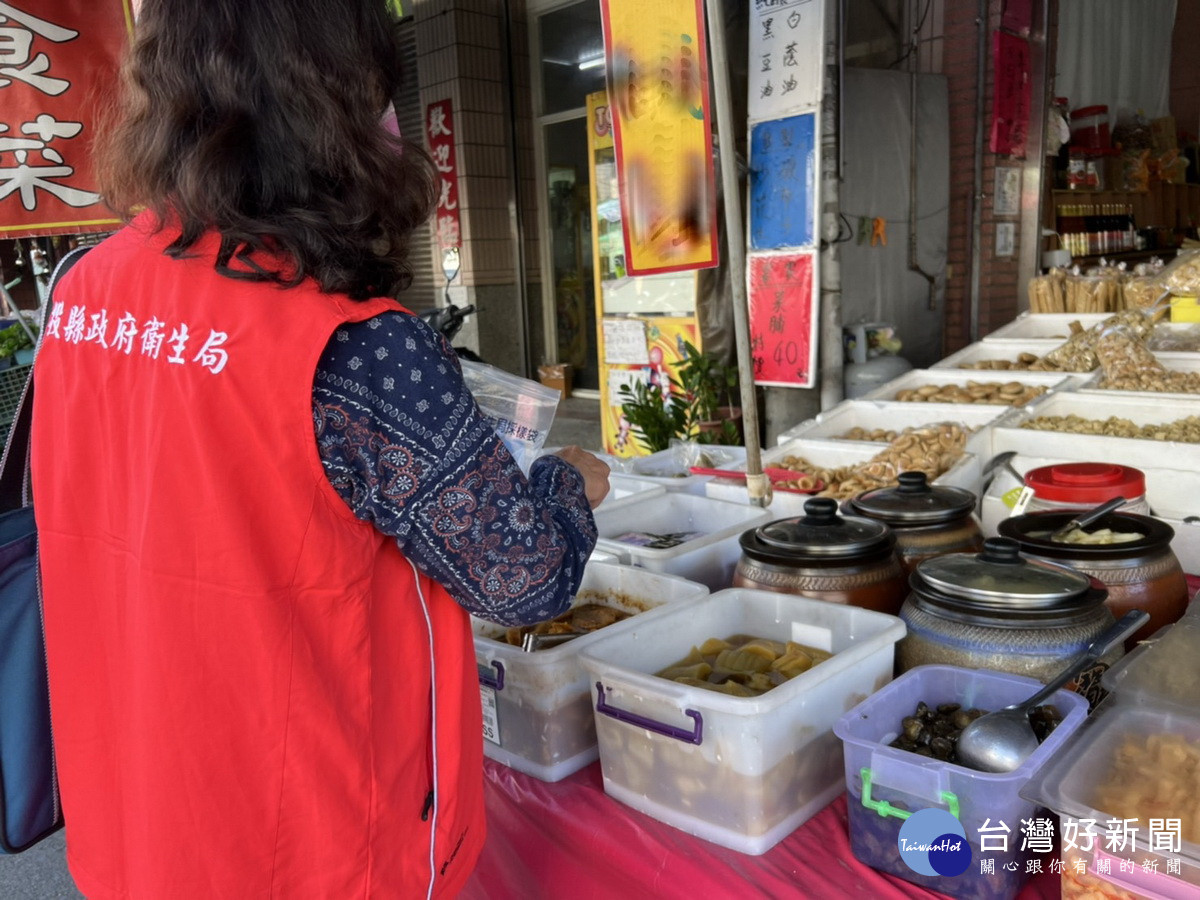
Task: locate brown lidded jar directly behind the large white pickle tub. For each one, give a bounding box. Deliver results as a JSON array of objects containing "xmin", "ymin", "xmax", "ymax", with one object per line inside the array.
[{"xmin": 733, "ymin": 497, "xmax": 906, "ymax": 616}]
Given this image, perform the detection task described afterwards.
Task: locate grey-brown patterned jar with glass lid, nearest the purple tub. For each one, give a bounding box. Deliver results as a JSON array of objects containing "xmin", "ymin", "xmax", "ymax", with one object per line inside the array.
[{"xmin": 896, "ymin": 538, "xmax": 1124, "ymax": 700}]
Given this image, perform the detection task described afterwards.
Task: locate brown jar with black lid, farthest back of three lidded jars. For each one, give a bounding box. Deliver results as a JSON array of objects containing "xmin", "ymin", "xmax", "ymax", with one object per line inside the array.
[{"xmin": 847, "ymin": 472, "xmax": 983, "ymax": 574}]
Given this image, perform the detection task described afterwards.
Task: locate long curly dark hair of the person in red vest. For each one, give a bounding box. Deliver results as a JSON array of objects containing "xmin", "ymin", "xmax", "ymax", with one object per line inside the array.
[{"xmin": 97, "ymin": 0, "xmax": 437, "ymax": 300}]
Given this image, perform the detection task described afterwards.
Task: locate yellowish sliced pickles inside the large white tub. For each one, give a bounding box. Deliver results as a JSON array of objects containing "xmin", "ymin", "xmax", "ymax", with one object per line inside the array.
[{"xmin": 655, "ymin": 635, "xmax": 833, "ymax": 697}]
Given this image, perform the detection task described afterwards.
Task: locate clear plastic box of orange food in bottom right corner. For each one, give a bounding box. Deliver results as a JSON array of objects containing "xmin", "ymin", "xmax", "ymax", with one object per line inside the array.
[{"xmin": 1021, "ymin": 694, "xmax": 1200, "ymax": 900}]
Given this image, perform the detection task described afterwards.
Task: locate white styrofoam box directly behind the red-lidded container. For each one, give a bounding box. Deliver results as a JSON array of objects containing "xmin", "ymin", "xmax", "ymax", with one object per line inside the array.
[{"xmin": 979, "ymin": 453, "xmax": 1200, "ymax": 575}]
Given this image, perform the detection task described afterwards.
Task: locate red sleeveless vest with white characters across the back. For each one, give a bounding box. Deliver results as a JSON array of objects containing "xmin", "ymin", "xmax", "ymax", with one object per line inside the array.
[{"xmin": 34, "ymin": 217, "xmax": 484, "ymax": 900}]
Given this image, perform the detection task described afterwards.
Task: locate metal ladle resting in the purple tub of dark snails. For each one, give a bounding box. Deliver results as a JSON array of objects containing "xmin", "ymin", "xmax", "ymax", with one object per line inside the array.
[{"xmin": 956, "ymin": 610, "xmax": 1150, "ymax": 772}]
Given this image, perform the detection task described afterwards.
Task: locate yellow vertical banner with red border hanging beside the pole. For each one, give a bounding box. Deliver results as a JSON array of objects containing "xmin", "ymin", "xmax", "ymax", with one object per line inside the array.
[{"xmin": 600, "ymin": 0, "xmax": 718, "ymax": 275}]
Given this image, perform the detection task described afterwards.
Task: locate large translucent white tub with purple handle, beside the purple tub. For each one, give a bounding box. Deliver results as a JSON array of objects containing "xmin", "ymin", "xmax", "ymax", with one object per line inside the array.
[{"xmin": 580, "ymin": 589, "xmax": 904, "ymax": 854}]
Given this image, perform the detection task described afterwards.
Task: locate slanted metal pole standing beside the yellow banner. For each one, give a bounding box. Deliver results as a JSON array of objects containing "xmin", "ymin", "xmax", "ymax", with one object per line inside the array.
[{"xmin": 704, "ymin": 0, "xmax": 770, "ymax": 506}]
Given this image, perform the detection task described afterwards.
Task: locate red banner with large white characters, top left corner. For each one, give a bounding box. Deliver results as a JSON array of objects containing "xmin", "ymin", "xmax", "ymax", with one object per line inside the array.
[{"xmin": 0, "ymin": 0, "xmax": 133, "ymax": 238}]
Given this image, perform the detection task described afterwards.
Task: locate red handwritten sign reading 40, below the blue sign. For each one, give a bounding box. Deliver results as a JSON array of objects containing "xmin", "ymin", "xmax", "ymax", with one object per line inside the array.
[{"xmin": 749, "ymin": 251, "xmax": 817, "ymax": 388}]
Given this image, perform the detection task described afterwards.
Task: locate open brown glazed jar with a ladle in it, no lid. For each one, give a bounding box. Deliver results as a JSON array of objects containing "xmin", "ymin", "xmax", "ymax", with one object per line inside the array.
[{"xmin": 1000, "ymin": 510, "xmax": 1188, "ymax": 649}]
